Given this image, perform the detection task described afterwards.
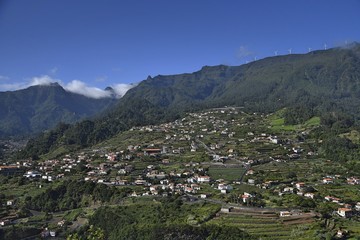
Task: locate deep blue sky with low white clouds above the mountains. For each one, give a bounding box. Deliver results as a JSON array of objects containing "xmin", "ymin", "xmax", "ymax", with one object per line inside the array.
[{"xmin": 0, "ymin": 0, "xmax": 360, "ymax": 96}]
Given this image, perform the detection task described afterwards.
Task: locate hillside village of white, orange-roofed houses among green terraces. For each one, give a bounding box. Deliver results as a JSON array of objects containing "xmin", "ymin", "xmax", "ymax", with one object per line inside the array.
[{"xmin": 0, "ymin": 107, "xmax": 360, "ymax": 239}]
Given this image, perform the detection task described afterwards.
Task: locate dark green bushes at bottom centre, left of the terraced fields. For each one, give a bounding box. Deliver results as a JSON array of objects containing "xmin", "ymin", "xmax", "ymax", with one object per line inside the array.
[{"xmin": 84, "ymin": 199, "xmax": 251, "ymax": 240}]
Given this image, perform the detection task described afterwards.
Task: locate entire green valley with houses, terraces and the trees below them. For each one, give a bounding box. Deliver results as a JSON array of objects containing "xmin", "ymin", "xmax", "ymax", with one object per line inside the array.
[{"xmin": 0, "ymin": 107, "xmax": 360, "ymax": 239}]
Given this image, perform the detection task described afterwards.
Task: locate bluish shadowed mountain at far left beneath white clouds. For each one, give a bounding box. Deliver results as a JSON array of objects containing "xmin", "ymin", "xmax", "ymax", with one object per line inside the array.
[{"xmin": 0, "ymin": 83, "xmax": 115, "ymax": 137}]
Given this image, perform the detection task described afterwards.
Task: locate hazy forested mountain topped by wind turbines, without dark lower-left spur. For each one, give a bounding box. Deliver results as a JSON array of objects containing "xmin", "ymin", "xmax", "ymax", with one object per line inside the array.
[{"xmin": 123, "ymin": 44, "xmax": 360, "ymax": 111}]
